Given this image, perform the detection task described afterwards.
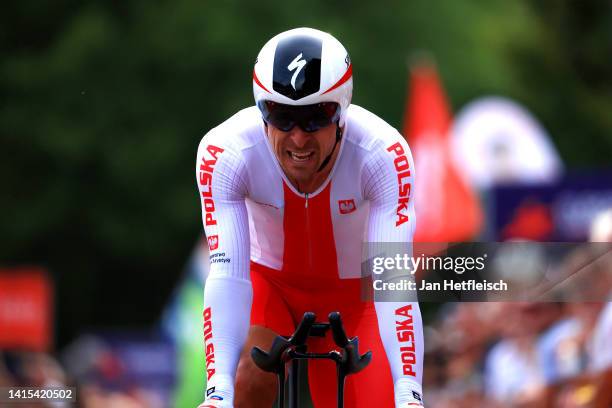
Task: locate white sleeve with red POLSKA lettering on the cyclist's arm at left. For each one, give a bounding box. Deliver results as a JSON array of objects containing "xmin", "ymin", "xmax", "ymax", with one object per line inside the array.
[{"xmin": 196, "ymin": 134, "xmax": 253, "ymax": 405}]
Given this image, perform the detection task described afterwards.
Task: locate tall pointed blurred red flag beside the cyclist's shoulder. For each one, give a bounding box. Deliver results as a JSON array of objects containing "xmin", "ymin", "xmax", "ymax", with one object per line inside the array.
[{"xmin": 404, "ymin": 63, "xmax": 483, "ymax": 242}]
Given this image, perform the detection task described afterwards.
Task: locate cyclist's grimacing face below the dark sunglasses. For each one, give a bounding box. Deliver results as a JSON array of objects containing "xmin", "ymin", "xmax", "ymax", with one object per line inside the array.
[{"xmin": 267, "ymin": 124, "xmax": 336, "ymax": 184}]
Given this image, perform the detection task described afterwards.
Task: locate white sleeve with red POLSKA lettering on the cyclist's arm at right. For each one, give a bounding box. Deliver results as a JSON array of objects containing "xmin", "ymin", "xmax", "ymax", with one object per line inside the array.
[{"xmin": 362, "ymin": 134, "xmax": 424, "ymax": 406}]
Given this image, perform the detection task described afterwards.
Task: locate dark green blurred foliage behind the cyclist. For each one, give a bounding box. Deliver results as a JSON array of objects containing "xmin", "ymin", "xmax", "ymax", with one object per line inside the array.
[{"xmin": 0, "ymin": 0, "xmax": 612, "ymax": 346}]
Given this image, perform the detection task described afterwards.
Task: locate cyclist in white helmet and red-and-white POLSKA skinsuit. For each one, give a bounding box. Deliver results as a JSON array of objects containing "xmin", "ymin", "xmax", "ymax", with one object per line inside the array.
[{"xmin": 196, "ymin": 28, "xmax": 423, "ymax": 408}]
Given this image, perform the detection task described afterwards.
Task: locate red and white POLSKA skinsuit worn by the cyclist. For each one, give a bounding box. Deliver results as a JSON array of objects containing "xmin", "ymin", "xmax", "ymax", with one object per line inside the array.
[{"xmin": 196, "ymin": 105, "xmax": 423, "ymax": 408}]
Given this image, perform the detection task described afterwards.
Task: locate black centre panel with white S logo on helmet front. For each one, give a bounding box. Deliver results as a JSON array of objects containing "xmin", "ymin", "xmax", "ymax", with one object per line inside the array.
[{"xmin": 272, "ymin": 35, "xmax": 323, "ymax": 101}]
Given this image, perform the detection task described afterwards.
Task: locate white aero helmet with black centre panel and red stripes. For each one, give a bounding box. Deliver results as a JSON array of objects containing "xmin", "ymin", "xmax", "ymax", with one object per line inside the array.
[{"xmin": 253, "ymin": 28, "xmax": 353, "ymax": 126}]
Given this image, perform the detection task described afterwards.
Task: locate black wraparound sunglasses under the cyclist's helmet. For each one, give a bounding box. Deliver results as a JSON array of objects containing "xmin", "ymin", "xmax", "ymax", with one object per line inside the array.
[{"xmin": 257, "ymin": 101, "xmax": 340, "ymax": 132}]
